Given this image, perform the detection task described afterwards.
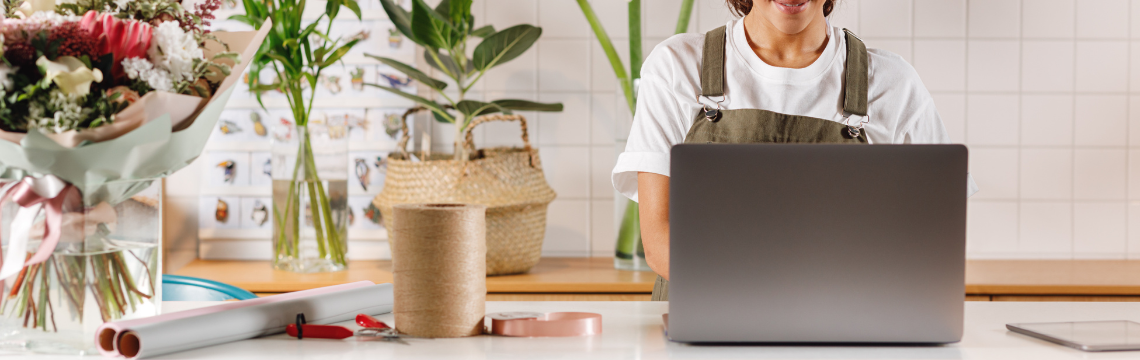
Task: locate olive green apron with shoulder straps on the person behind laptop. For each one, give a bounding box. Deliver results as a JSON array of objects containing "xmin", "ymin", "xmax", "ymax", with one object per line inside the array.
[{"xmin": 652, "ymin": 26, "xmax": 868, "ymax": 301}]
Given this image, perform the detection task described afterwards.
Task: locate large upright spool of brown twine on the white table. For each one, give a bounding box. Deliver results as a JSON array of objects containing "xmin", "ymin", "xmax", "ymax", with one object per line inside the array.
[{"xmin": 392, "ymin": 204, "xmax": 487, "ymax": 337}]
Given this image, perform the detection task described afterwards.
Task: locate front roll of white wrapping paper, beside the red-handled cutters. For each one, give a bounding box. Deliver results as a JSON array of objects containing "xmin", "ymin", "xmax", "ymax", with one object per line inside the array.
[{"xmin": 110, "ymin": 284, "xmax": 392, "ymax": 359}]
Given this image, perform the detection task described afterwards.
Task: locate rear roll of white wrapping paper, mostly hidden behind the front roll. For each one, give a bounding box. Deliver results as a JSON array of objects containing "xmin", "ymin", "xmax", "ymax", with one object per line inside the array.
[{"xmin": 95, "ymin": 280, "xmax": 376, "ymax": 357}]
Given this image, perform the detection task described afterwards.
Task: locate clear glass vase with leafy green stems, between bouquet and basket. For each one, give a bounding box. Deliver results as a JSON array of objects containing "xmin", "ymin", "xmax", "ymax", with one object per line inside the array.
[{"xmin": 230, "ymin": 0, "xmax": 360, "ymax": 272}]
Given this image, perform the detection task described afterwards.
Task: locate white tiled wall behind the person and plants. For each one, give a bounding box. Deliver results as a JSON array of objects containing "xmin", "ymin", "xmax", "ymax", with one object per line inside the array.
[{"xmin": 168, "ymin": 0, "xmax": 1140, "ymax": 259}]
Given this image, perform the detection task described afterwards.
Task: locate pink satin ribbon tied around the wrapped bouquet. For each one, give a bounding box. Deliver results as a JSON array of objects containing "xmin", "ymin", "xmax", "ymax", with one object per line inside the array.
[{"xmin": 0, "ymin": 175, "xmax": 79, "ymax": 275}]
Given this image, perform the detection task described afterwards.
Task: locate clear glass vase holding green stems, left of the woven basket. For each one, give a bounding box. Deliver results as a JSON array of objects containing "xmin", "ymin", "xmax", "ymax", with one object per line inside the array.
[{"xmin": 271, "ymin": 118, "xmax": 349, "ymax": 272}]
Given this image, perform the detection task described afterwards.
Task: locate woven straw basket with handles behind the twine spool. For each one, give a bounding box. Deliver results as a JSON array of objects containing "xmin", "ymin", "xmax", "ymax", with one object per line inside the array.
[{"xmin": 373, "ymin": 111, "xmax": 555, "ymax": 275}]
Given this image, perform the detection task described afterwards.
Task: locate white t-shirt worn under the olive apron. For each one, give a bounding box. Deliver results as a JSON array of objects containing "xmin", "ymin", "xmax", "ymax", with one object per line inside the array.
[{"xmin": 613, "ymin": 19, "xmax": 977, "ymax": 201}]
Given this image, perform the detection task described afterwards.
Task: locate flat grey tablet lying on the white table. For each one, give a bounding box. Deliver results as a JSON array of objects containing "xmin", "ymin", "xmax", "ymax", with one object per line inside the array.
[{"xmin": 1005, "ymin": 320, "xmax": 1140, "ymax": 351}]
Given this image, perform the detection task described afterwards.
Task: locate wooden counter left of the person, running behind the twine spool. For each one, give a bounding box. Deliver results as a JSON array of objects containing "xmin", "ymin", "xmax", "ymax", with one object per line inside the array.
[{"xmin": 167, "ymin": 257, "xmax": 657, "ymax": 294}]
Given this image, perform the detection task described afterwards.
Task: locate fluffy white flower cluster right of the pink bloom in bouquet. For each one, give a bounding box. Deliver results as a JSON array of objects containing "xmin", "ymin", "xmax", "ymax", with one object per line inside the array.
[{"xmin": 147, "ymin": 22, "xmax": 205, "ymax": 83}]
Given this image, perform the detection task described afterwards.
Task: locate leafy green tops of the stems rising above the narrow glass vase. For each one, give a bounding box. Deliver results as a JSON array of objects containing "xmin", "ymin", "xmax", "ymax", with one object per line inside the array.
[{"xmin": 230, "ymin": 0, "xmax": 361, "ymax": 126}]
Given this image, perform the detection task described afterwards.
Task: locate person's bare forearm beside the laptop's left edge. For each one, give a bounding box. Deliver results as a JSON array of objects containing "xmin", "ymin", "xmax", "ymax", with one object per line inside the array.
[{"xmin": 637, "ymin": 172, "xmax": 669, "ymax": 280}]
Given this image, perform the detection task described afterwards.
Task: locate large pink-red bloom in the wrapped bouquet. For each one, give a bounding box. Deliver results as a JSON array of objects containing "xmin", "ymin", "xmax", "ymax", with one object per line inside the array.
[{"xmin": 79, "ymin": 10, "xmax": 152, "ymax": 79}]
